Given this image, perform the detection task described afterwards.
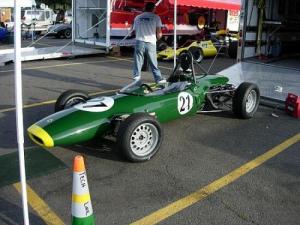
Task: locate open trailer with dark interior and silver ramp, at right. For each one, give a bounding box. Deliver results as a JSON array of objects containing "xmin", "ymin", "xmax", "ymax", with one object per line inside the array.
[{"xmin": 220, "ymin": 0, "xmax": 300, "ymax": 101}]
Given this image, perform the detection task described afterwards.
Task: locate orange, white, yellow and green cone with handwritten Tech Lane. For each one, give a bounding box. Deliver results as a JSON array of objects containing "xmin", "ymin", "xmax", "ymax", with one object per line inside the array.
[{"xmin": 72, "ymin": 155, "xmax": 95, "ymax": 225}]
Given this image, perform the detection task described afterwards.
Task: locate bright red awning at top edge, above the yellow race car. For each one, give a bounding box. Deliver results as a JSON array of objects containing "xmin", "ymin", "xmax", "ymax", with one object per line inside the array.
[{"xmin": 169, "ymin": 0, "xmax": 241, "ymax": 10}]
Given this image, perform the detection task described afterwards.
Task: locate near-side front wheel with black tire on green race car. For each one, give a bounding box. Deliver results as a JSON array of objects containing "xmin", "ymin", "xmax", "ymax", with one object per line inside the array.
[{"xmin": 117, "ymin": 113, "xmax": 163, "ymax": 162}]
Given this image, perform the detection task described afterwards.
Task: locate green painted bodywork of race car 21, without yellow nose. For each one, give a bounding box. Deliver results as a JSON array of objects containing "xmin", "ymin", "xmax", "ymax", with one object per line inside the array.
[{"xmin": 28, "ymin": 75, "xmax": 228, "ymax": 146}]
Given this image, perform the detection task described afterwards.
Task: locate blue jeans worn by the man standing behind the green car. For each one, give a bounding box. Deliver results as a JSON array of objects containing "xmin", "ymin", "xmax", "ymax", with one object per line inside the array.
[{"xmin": 133, "ymin": 40, "xmax": 162, "ymax": 83}]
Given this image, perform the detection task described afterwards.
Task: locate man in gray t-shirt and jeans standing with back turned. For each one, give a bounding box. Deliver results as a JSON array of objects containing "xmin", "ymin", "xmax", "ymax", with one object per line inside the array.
[{"xmin": 133, "ymin": 2, "xmax": 166, "ymax": 83}]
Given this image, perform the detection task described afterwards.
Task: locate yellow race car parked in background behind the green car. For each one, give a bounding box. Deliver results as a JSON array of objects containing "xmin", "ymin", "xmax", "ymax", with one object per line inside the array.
[{"xmin": 157, "ymin": 40, "xmax": 217, "ymax": 62}]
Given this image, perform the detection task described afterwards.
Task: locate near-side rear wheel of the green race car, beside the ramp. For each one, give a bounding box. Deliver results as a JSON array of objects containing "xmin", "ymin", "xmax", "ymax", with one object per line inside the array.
[{"xmin": 232, "ymin": 82, "xmax": 260, "ymax": 119}]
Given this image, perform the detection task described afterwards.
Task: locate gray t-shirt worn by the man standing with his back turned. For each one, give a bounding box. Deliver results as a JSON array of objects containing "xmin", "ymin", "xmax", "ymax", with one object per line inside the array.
[{"xmin": 133, "ymin": 12, "xmax": 162, "ymax": 44}]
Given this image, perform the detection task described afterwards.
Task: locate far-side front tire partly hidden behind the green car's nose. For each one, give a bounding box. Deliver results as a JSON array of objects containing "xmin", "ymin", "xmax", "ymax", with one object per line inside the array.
[{"xmin": 54, "ymin": 90, "xmax": 89, "ymax": 112}]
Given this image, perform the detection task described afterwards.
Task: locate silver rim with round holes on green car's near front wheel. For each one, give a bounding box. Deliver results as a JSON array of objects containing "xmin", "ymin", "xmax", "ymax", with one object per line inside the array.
[{"xmin": 130, "ymin": 123, "xmax": 159, "ymax": 156}]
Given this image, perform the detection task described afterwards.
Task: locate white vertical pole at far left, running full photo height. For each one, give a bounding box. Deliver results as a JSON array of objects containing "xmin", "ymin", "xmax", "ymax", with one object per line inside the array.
[{"xmin": 14, "ymin": 0, "xmax": 29, "ymax": 225}]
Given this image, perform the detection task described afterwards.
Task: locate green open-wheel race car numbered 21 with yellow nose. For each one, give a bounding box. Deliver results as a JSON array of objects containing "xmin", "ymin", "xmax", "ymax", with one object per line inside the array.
[{"xmin": 28, "ymin": 53, "xmax": 260, "ymax": 162}]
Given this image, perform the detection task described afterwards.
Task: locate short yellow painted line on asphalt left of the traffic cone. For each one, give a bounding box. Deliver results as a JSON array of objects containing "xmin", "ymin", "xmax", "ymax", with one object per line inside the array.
[{"xmin": 13, "ymin": 183, "xmax": 65, "ymax": 225}]
